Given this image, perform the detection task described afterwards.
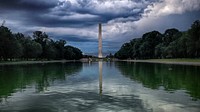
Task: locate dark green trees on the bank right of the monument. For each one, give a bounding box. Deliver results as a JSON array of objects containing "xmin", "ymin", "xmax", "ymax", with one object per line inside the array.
[{"xmin": 114, "ymin": 20, "xmax": 200, "ymax": 59}]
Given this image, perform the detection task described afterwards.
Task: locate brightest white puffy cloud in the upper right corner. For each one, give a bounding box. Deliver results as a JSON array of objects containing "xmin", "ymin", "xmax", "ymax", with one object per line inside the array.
[{"xmin": 143, "ymin": 0, "xmax": 200, "ymax": 17}]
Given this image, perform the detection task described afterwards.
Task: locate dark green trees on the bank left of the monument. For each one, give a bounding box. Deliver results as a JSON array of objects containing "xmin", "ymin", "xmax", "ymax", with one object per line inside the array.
[{"xmin": 0, "ymin": 26, "xmax": 83, "ymax": 61}]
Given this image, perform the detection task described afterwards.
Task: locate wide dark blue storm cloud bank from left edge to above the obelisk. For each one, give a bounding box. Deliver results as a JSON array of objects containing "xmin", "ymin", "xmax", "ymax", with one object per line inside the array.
[{"xmin": 0, "ymin": 0, "xmax": 148, "ymax": 27}]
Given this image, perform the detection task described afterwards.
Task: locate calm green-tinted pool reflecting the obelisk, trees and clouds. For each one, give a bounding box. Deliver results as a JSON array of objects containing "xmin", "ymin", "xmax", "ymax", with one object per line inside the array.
[{"xmin": 0, "ymin": 62, "xmax": 200, "ymax": 112}]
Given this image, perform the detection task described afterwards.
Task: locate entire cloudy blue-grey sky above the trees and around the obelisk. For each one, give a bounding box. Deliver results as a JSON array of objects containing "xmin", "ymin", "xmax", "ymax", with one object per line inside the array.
[{"xmin": 0, "ymin": 0, "xmax": 200, "ymax": 55}]
